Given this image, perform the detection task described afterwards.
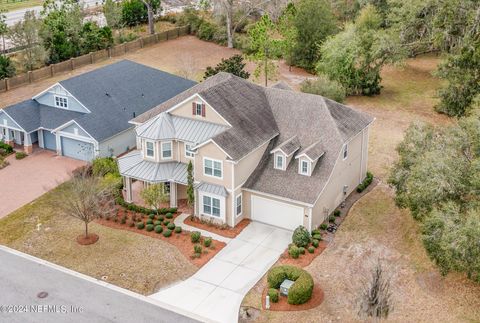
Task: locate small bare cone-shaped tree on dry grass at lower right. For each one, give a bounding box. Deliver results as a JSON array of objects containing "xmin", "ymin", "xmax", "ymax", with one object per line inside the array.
[{"xmin": 358, "ymin": 261, "xmax": 393, "ymax": 321}]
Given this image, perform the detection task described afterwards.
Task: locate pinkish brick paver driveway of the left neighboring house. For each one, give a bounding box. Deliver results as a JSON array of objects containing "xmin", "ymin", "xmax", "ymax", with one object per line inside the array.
[{"xmin": 0, "ymin": 149, "xmax": 85, "ymax": 218}]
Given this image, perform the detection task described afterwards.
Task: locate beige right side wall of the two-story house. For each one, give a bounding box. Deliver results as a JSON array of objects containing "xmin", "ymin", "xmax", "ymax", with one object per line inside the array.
[{"xmin": 312, "ymin": 128, "xmax": 368, "ymax": 228}]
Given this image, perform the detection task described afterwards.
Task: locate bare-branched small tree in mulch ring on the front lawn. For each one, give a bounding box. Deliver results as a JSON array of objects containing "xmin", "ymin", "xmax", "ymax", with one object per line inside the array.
[{"xmin": 57, "ymin": 172, "xmax": 115, "ymax": 243}]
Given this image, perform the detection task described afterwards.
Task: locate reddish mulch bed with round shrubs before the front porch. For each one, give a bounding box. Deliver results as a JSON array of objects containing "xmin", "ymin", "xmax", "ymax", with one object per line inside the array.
[{"xmin": 95, "ymin": 210, "xmax": 225, "ymax": 268}]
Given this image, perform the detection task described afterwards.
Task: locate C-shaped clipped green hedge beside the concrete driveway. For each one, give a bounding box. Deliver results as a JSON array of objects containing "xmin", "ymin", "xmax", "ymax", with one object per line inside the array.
[{"xmin": 267, "ymin": 265, "xmax": 314, "ymax": 305}]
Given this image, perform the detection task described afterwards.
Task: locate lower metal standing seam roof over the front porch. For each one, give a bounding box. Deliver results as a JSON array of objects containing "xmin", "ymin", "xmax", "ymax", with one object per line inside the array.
[{"xmin": 118, "ymin": 150, "xmax": 187, "ymax": 185}]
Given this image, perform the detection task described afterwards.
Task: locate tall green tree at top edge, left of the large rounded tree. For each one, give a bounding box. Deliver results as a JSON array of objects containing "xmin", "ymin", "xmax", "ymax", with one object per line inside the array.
[{"xmin": 294, "ymin": 0, "xmax": 338, "ymax": 70}]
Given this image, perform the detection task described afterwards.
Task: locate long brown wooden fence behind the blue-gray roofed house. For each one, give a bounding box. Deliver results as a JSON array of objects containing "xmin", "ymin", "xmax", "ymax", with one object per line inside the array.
[{"xmin": 0, "ymin": 26, "xmax": 188, "ymax": 92}]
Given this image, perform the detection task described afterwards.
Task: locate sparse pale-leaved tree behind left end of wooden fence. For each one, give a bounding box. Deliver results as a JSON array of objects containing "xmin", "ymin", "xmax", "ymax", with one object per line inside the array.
[{"xmin": 8, "ymin": 11, "xmax": 47, "ymax": 71}]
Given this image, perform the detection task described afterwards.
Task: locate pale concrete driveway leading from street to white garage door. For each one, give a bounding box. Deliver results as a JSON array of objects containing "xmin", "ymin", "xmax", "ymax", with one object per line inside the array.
[{"xmin": 150, "ymin": 222, "xmax": 292, "ymax": 322}]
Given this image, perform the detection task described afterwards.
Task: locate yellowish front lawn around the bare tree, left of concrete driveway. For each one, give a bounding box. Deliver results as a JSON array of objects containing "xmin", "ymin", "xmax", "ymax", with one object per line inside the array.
[{"xmin": 0, "ymin": 185, "xmax": 197, "ymax": 295}]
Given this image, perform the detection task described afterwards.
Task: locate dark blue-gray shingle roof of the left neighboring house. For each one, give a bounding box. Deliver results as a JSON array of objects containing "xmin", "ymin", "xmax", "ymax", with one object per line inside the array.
[{"xmin": 6, "ymin": 60, "xmax": 196, "ymax": 142}]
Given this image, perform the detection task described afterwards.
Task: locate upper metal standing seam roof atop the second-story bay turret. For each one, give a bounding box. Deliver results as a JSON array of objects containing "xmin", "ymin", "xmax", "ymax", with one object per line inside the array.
[{"xmin": 136, "ymin": 112, "xmax": 228, "ymax": 144}]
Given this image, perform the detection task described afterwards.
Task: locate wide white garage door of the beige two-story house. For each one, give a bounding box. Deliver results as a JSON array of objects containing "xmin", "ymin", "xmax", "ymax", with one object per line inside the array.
[{"xmin": 252, "ymin": 195, "xmax": 303, "ymax": 230}]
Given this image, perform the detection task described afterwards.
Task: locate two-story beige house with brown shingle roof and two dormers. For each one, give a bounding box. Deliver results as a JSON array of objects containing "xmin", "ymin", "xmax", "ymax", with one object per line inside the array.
[{"xmin": 118, "ymin": 73, "xmax": 374, "ymax": 230}]
